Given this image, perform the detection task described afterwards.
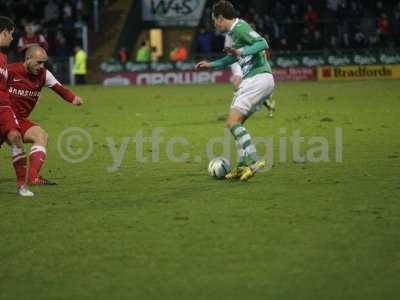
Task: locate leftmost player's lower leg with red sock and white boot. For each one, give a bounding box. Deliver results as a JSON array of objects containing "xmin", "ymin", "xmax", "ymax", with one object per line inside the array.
[{"xmin": 7, "ymin": 130, "xmax": 34, "ymax": 197}]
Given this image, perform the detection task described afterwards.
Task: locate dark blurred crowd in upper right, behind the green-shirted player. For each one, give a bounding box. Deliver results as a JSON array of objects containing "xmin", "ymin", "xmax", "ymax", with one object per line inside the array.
[{"xmin": 196, "ymin": 0, "xmax": 400, "ymax": 54}]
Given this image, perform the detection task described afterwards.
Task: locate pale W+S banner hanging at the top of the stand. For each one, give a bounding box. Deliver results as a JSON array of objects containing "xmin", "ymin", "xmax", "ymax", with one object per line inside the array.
[{"xmin": 142, "ymin": 0, "xmax": 206, "ymax": 27}]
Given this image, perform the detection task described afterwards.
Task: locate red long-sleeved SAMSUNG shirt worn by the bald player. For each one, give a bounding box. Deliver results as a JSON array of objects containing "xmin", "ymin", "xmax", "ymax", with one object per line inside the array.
[{"xmin": 8, "ymin": 63, "xmax": 75, "ymax": 119}]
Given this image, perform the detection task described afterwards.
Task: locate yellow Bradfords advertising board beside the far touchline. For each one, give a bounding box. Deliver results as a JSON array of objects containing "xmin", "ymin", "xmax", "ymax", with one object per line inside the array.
[{"xmin": 318, "ymin": 65, "xmax": 400, "ymax": 80}]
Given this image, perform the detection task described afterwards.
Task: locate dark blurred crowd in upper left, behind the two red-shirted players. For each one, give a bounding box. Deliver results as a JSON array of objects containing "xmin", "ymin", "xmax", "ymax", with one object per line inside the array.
[{"xmin": 0, "ymin": 0, "xmax": 88, "ymax": 60}]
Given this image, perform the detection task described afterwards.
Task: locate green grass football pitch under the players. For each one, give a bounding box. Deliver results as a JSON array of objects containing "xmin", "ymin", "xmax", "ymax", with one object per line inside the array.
[{"xmin": 0, "ymin": 81, "xmax": 400, "ymax": 299}]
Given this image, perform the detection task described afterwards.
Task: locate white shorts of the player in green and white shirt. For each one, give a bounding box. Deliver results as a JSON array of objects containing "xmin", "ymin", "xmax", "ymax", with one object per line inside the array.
[{"xmin": 231, "ymin": 73, "xmax": 275, "ymax": 117}]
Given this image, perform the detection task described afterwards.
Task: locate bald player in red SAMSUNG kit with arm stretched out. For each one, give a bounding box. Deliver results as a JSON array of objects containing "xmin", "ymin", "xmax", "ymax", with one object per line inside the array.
[{"xmin": 8, "ymin": 46, "xmax": 83, "ymax": 185}]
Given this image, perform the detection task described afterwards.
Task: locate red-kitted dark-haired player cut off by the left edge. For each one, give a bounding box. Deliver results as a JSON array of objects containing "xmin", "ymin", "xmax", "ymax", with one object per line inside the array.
[{"xmin": 0, "ymin": 16, "xmax": 33, "ymax": 196}]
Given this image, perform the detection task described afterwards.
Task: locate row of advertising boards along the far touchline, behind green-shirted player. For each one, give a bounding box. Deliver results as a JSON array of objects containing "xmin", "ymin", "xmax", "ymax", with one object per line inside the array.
[{"xmin": 100, "ymin": 49, "xmax": 400, "ymax": 85}]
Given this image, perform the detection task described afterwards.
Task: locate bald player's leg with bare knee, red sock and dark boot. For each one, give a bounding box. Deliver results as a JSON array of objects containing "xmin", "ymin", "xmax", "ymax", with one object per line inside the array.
[{"xmin": 24, "ymin": 126, "xmax": 56, "ymax": 185}]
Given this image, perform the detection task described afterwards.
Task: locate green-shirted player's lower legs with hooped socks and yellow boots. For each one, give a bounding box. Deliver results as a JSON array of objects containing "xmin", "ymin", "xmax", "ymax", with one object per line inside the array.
[{"xmin": 226, "ymin": 108, "xmax": 265, "ymax": 181}]
